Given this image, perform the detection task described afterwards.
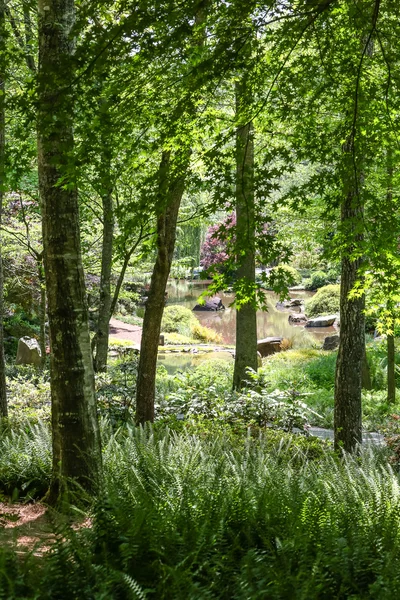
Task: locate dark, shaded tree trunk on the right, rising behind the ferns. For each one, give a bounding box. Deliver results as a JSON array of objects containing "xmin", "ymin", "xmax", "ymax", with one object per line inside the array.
[{"xmin": 334, "ymin": 191, "xmax": 365, "ymax": 452}]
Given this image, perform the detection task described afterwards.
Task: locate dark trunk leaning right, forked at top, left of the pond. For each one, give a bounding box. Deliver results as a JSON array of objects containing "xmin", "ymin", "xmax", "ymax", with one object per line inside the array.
[{"xmin": 136, "ymin": 151, "xmax": 186, "ymax": 424}]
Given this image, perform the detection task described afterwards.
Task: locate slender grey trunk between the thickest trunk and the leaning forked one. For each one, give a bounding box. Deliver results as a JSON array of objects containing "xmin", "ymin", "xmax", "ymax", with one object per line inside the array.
[{"xmin": 94, "ymin": 187, "xmax": 114, "ymax": 372}]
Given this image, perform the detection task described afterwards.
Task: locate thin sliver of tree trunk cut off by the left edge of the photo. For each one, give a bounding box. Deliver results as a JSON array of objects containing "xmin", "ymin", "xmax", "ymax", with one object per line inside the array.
[{"xmin": 0, "ymin": 0, "xmax": 7, "ymax": 417}]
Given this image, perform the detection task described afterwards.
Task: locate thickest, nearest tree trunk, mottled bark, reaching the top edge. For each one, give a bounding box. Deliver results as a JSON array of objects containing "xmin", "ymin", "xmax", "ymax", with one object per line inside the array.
[{"xmin": 38, "ymin": 0, "xmax": 101, "ymax": 502}]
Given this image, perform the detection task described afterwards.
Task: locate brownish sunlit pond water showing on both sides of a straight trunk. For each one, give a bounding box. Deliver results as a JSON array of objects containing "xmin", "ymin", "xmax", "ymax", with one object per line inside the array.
[{"xmin": 167, "ymin": 280, "xmax": 336, "ymax": 346}]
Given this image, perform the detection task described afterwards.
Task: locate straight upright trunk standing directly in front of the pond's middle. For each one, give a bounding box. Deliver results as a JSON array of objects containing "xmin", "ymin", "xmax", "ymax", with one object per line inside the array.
[{"xmin": 233, "ymin": 82, "xmax": 258, "ymax": 389}]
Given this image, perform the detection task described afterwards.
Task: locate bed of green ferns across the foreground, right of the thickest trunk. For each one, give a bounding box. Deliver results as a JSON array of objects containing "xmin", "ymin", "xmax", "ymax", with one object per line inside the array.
[{"xmin": 0, "ymin": 427, "xmax": 400, "ymax": 600}]
